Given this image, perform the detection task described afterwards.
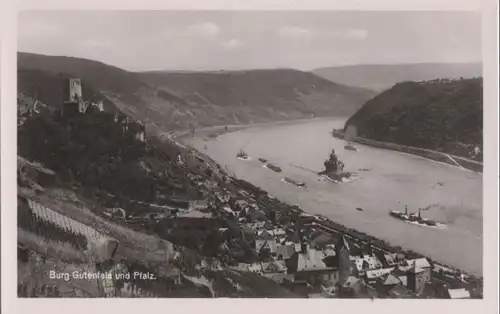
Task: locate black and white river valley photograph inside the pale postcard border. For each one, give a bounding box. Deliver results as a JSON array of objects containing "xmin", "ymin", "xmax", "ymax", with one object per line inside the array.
[{"xmin": 2, "ymin": 4, "xmax": 498, "ymax": 302}]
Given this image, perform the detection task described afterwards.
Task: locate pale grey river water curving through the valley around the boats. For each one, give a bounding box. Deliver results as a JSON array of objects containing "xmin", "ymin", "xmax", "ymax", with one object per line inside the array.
[{"xmin": 183, "ymin": 119, "xmax": 483, "ymax": 275}]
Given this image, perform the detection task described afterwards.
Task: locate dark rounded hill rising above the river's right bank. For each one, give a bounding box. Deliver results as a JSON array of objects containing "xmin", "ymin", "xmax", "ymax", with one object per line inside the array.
[{"xmin": 345, "ymin": 78, "xmax": 483, "ymax": 160}]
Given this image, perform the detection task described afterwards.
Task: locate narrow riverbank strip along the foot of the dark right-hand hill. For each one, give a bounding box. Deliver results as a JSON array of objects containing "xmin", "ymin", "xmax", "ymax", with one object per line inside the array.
[{"xmin": 332, "ymin": 129, "xmax": 483, "ymax": 173}]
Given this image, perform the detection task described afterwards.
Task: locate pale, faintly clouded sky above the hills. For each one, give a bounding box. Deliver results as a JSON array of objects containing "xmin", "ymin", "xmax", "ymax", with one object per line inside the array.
[{"xmin": 18, "ymin": 11, "xmax": 482, "ymax": 71}]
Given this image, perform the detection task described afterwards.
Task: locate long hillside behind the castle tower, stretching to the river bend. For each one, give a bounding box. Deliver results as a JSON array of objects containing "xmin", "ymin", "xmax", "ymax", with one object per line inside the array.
[{"xmin": 18, "ymin": 52, "xmax": 375, "ymax": 129}]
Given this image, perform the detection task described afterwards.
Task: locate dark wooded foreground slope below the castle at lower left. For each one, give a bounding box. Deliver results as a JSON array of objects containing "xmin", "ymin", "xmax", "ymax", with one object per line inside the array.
[{"xmin": 18, "ymin": 112, "xmax": 296, "ymax": 298}]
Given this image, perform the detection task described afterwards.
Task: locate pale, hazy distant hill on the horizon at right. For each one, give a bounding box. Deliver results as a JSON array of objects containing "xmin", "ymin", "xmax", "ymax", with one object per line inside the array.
[{"xmin": 313, "ymin": 63, "xmax": 482, "ymax": 91}]
